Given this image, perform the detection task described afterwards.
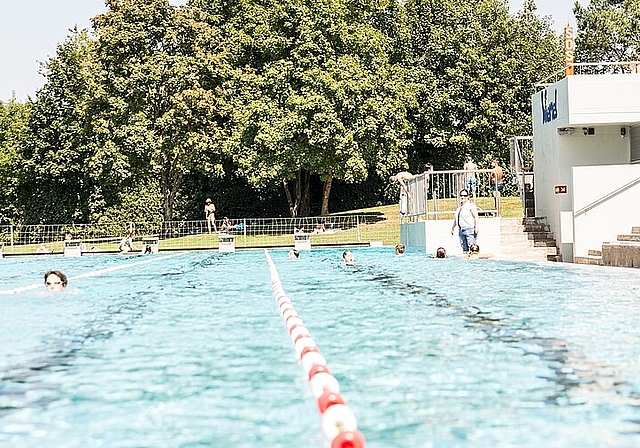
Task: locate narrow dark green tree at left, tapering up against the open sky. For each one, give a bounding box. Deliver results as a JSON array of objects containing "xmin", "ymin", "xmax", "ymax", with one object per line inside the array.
[{"xmin": 20, "ymin": 30, "xmax": 104, "ymax": 223}]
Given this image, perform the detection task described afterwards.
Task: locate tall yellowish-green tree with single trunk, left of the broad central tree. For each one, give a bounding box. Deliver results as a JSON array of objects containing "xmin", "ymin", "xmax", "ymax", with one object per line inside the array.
[{"xmin": 94, "ymin": 0, "xmax": 228, "ymax": 221}]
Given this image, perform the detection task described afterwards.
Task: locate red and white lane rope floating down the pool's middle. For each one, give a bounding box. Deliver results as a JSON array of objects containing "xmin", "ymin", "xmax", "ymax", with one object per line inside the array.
[{"xmin": 264, "ymin": 249, "xmax": 367, "ymax": 448}]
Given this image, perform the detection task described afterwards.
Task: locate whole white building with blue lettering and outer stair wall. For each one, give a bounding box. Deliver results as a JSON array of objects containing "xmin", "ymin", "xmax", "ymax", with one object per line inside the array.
[{"xmin": 531, "ymin": 72, "xmax": 640, "ymax": 262}]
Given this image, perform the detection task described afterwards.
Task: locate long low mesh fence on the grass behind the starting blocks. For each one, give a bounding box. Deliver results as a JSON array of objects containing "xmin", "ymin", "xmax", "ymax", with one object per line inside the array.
[{"xmin": 0, "ymin": 214, "xmax": 390, "ymax": 255}]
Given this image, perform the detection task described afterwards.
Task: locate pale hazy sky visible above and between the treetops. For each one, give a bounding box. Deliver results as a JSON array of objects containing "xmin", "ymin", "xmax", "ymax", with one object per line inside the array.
[{"xmin": 0, "ymin": 0, "xmax": 588, "ymax": 102}]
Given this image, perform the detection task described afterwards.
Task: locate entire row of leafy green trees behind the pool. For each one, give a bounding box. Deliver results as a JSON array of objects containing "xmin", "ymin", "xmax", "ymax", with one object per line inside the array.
[{"xmin": 0, "ymin": 0, "xmax": 568, "ymax": 223}]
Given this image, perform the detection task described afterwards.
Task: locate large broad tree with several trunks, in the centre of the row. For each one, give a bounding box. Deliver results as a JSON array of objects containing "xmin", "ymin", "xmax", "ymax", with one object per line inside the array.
[{"xmin": 229, "ymin": 0, "xmax": 412, "ymax": 216}]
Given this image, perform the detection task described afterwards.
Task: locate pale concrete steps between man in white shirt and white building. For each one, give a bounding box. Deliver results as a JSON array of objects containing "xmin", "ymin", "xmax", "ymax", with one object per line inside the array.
[{"xmin": 500, "ymin": 217, "xmax": 562, "ymax": 261}]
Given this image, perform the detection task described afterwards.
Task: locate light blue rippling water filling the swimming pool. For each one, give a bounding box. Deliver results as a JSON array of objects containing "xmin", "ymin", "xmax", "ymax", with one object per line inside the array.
[{"xmin": 0, "ymin": 248, "xmax": 640, "ymax": 448}]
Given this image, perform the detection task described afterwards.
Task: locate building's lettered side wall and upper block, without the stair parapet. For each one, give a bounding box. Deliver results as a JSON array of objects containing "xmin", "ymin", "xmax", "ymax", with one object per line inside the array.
[{"xmin": 531, "ymin": 74, "xmax": 640, "ymax": 261}]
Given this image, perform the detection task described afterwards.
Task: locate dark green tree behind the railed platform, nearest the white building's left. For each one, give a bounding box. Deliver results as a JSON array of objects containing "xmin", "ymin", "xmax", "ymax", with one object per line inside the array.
[{"xmin": 406, "ymin": 0, "xmax": 562, "ymax": 170}]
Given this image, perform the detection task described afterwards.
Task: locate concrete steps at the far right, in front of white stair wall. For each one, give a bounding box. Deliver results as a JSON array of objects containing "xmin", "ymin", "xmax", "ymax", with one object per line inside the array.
[{"xmin": 573, "ymin": 227, "xmax": 640, "ymax": 268}]
